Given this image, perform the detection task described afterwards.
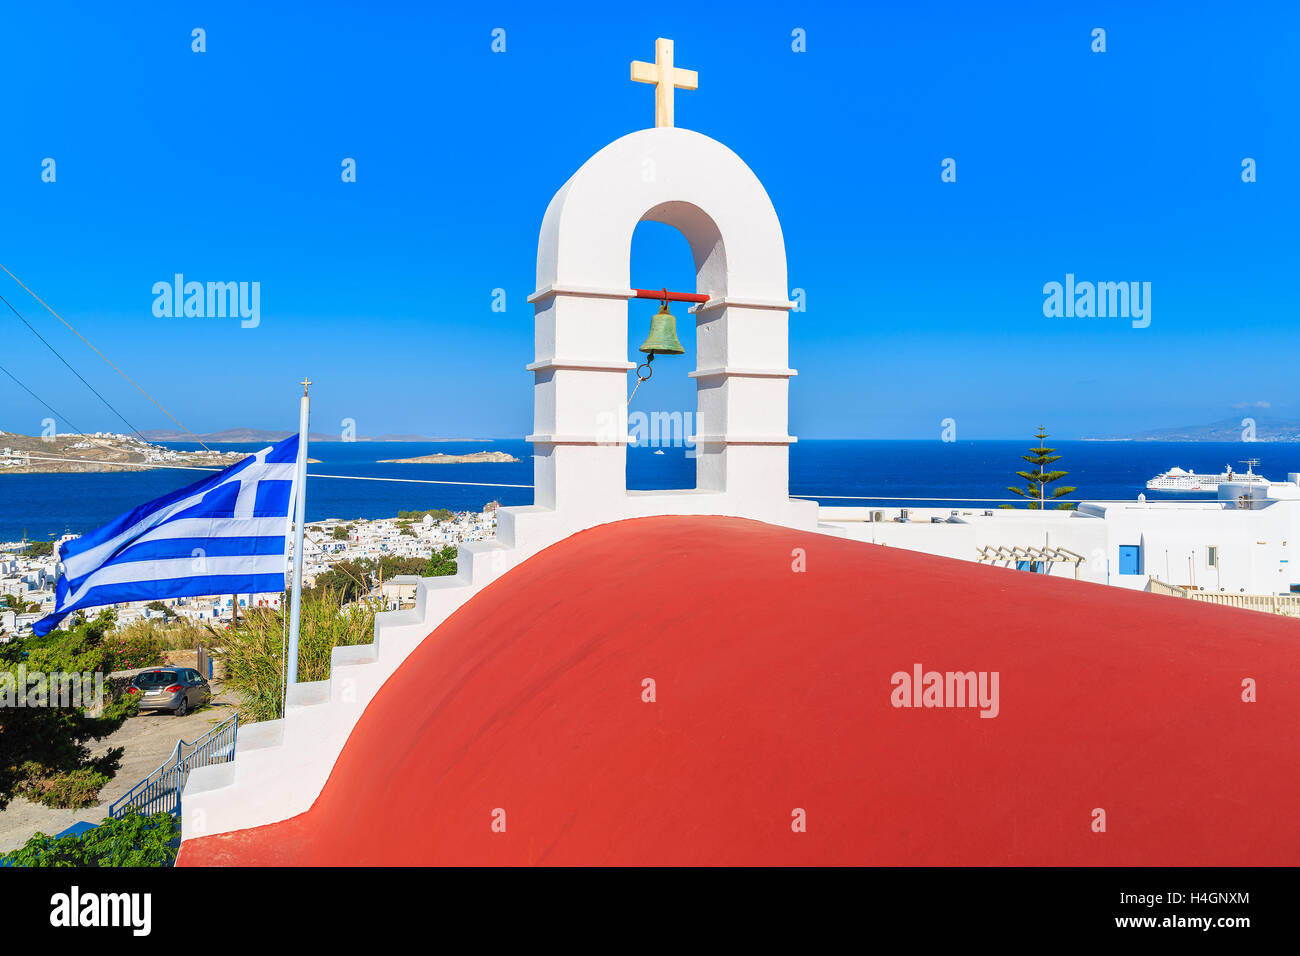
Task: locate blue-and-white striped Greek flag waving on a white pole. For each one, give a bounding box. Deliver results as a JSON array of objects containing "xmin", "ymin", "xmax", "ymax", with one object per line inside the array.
[{"xmin": 31, "ymin": 434, "xmax": 298, "ymax": 636}]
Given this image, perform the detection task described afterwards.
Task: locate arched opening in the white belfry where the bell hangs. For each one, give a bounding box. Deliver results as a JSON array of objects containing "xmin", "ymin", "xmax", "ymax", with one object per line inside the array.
[{"xmin": 627, "ymin": 220, "xmax": 697, "ymax": 490}]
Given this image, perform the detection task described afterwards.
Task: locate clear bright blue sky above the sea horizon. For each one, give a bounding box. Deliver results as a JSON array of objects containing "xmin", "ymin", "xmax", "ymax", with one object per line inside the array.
[{"xmin": 0, "ymin": 0, "xmax": 1300, "ymax": 438}]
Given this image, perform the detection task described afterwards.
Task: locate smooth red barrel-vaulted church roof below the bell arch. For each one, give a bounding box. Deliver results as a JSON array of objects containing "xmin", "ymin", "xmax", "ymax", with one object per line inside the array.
[{"xmin": 181, "ymin": 518, "xmax": 1300, "ymax": 865}]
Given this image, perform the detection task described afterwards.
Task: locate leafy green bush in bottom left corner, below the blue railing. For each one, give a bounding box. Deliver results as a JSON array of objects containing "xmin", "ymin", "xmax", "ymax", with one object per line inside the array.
[{"xmin": 0, "ymin": 813, "xmax": 181, "ymax": 866}]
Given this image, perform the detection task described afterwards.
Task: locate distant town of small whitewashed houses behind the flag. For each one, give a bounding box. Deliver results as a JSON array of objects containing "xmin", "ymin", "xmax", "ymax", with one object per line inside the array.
[{"xmin": 0, "ymin": 502, "xmax": 497, "ymax": 643}]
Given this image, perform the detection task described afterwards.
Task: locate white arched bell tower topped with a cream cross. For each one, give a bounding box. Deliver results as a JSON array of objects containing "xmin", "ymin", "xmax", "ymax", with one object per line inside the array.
[{"xmin": 496, "ymin": 39, "xmax": 816, "ymax": 546}]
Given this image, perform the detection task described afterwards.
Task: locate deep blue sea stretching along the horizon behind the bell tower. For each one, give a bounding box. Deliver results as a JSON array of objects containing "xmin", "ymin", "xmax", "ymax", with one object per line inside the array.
[{"xmin": 0, "ymin": 440, "xmax": 1300, "ymax": 541}]
